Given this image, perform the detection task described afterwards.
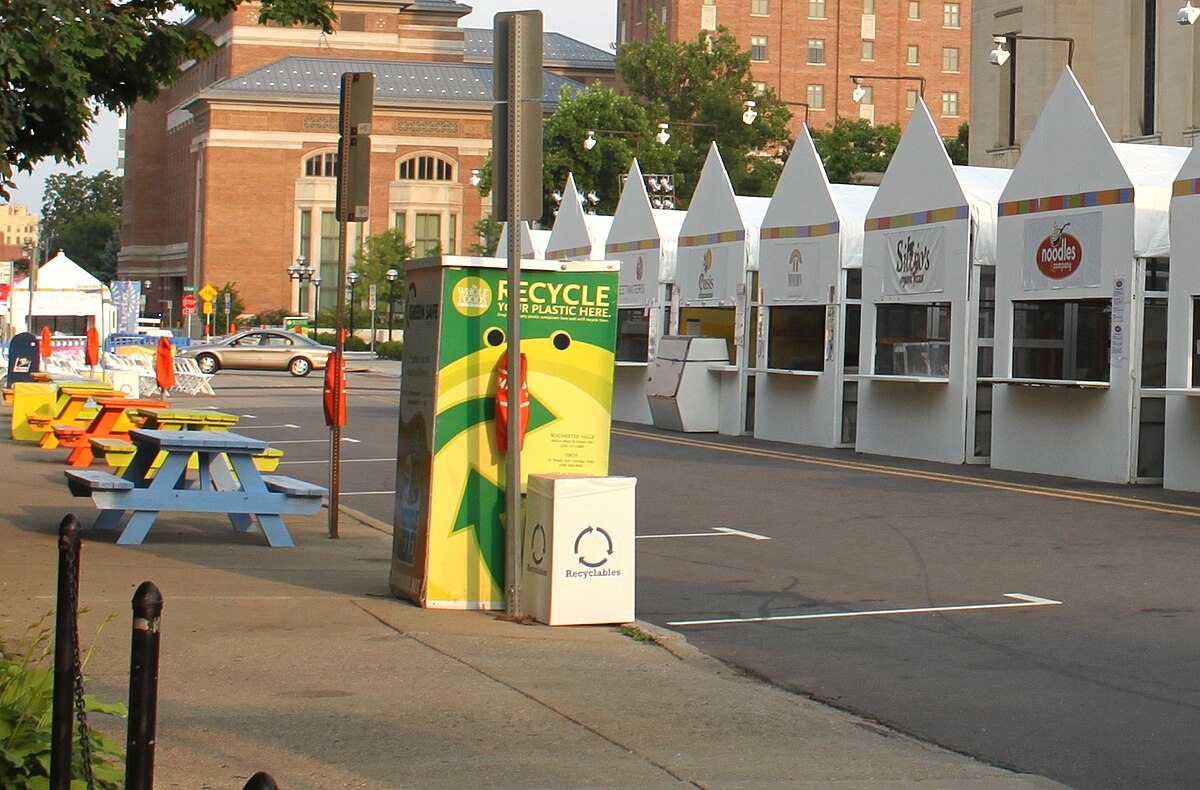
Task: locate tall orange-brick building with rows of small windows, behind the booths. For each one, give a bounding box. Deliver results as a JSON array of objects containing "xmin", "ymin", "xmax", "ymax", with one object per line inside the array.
[{"xmin": 617, "ymin": 0, "xmax": 972, "ymax": 137}]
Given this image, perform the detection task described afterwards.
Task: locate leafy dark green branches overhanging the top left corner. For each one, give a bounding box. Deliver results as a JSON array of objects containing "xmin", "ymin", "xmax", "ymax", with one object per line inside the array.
[{"xmin": 0, "ymin": 0, "xmax": 335, "ymax": 198}]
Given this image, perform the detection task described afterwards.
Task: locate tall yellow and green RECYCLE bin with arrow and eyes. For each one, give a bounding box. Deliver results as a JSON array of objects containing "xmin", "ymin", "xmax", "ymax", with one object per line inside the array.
[{"xmin": 390, "ymin": 256, "xmax": 619, "ymax": 609}]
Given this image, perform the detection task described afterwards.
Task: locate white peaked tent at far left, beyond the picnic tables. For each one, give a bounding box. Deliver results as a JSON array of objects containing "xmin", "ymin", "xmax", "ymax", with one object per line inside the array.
[{"xmin": 8, "ymin": 250, "xmax": 116, "ymax": 337}]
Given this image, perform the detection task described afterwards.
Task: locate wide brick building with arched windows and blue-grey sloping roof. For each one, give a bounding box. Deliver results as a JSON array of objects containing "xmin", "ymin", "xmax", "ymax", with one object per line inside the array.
[{"xmin": 119, "ymin": 0, "xmax": 613, "ymax": 319}]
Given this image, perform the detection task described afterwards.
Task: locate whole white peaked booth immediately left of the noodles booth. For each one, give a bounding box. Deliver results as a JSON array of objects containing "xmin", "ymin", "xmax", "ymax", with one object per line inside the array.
[{"xmin": 847, "ymin": 101, "xmax": 1010, "ymax": 463}]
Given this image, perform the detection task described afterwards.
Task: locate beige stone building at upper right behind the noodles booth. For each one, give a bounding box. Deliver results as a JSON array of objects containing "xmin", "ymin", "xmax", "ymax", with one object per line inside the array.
[{"xmin": 971, "ymin": 0, "xmax": 1200, "ymax": 167}]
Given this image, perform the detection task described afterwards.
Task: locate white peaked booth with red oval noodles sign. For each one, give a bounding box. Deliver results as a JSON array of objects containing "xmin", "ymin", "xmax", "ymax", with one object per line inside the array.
[{"xmin": 991, "ymin": 68, "xmax": 1188, "ymax": 483}]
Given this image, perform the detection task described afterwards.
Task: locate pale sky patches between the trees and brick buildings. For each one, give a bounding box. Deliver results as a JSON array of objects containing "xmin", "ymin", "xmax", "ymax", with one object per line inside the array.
[{"xmin": 10, "ymin": 0, "xmax": 617, "ymax": 214}]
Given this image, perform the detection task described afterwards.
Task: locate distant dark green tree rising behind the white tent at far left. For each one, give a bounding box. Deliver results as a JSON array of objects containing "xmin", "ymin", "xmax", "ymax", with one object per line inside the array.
[{"xmin": 42, "ymin": 170, "xmax": 121, "ymax": 282}]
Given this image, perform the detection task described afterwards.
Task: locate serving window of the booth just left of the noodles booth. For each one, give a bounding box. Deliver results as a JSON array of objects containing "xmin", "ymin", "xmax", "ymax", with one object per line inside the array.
[{"xmin": 875, "ymin": 301, "xmax": 950, "ymax": 377}]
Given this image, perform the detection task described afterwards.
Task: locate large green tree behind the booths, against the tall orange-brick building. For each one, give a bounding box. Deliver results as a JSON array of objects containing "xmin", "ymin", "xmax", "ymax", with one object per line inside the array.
[{"xmin": 617, "ymin": 24, "xmax": 792, "ymax": 198}]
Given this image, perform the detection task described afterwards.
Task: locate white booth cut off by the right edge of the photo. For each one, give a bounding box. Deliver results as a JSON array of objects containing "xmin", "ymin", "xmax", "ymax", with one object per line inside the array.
[{"xmin": 1142, "ymin": 140, "xmax": 1200, "ymax": 491}]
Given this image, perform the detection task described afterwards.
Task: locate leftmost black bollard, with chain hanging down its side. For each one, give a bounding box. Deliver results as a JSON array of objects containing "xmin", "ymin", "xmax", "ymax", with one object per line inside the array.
[{"xmin": 50, "ymin": 514, "xmax": 79, "ymax": 790}]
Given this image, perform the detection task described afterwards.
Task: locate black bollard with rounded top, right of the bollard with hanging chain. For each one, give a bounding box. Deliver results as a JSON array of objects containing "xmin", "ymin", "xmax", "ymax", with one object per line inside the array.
[{"xmin": 125, "ymin": 581, "xmax": 162, "ymax": 790}]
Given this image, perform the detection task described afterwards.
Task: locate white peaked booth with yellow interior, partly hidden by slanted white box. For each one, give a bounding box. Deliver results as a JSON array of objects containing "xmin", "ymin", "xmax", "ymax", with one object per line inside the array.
[{"xmin": 674, "ymin": 143, "xmax": 770, "ymax": 436}]
